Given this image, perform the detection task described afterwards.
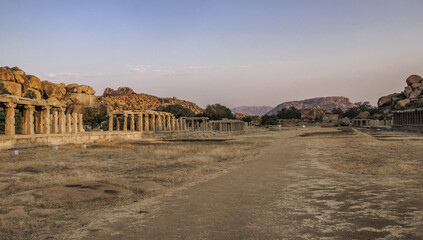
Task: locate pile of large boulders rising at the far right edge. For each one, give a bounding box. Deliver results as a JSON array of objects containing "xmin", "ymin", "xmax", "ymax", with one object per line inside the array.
[{"xmin": 377, "ymin": 75, "xmax": 423, "ymax": 112}]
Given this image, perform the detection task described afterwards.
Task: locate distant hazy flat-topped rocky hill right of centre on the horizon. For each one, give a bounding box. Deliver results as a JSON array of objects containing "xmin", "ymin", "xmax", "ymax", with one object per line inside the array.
[{"xmin": 266, "ymin": 97, "xmax": 354, "ymax": 115}]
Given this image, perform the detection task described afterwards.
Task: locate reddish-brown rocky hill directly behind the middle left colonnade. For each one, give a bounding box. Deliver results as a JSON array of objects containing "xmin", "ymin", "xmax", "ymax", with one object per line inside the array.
[{"xmin": 99, "ymin": 87, "xmax": 204, "ymax": 114}]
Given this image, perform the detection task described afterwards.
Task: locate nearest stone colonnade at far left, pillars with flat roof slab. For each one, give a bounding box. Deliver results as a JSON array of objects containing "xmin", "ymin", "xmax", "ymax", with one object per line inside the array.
[{"xmin": 0, "ymin": 95, "xmax": 84, "ymax": 136}]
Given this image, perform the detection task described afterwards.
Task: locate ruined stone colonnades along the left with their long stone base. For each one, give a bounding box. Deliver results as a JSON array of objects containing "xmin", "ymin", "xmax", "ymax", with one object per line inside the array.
[{"xmin": 0, "ymin": 94, "xmax": 246, "ymax": 149}]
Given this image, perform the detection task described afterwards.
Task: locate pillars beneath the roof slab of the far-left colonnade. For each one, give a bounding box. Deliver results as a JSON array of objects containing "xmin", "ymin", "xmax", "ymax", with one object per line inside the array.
[{"xmin": 3, "ymin": 103, "xmax": 84, "ymax": 136}]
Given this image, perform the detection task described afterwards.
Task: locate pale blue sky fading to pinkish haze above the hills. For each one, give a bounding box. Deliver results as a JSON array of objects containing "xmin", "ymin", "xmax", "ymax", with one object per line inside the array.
[{"xmin": 0, "ymin": 0, "xmax": 423, "ymax": 107}]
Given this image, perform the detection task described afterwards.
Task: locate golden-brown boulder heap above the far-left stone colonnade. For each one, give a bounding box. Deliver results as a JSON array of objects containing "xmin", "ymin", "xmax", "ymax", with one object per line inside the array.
[{"xmin": 0, "ymin": 66, "xmax": 99, "ymax": 112}]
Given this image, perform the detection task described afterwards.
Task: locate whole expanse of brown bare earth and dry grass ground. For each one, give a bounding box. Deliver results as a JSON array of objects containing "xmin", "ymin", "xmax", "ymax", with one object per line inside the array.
[{"xmin": 0, "ymin": 128, "xmax": 423, "ymax": 239}]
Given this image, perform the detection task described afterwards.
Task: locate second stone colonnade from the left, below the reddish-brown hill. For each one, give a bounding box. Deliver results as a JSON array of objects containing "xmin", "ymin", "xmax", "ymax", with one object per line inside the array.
[{"xmin": 109, "ymin": 110, "xmax": 186, "ymax": 132}]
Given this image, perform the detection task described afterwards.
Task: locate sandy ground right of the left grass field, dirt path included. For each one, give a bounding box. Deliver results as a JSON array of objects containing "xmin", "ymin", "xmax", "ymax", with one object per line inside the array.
[{"xmin": 57, "ymin": 128, "xmax": 423, "ymax": 239}]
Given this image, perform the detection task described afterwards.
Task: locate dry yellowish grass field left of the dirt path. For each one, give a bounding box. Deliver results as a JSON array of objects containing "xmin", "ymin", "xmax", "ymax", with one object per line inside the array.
[{"xmin": 0, "ymin": 131, "xmax": 274, "ymax": 239}]
